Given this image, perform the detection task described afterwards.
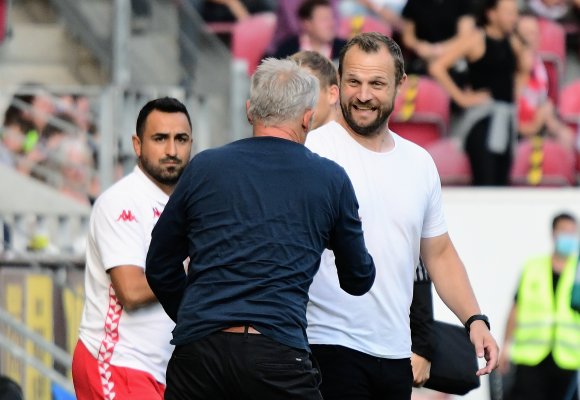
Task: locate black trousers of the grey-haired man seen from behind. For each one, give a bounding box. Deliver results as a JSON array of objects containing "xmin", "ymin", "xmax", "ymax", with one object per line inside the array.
[{"xmin": 165, "ymin": 332, "xmax": 322, "ymax": 400}]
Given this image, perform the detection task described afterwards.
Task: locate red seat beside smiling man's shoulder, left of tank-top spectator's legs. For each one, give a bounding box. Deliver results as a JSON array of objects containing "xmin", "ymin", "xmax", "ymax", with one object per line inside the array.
[{"xmin": 427, "ymin": 138, "xmax": 471, "ymax": 186}]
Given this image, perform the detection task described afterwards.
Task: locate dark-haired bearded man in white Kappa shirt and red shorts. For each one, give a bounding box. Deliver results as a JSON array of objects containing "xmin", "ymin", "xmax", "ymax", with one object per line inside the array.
[{"xmin": 72, "ymin": 97, "xmax": 192, "ymax": 400}]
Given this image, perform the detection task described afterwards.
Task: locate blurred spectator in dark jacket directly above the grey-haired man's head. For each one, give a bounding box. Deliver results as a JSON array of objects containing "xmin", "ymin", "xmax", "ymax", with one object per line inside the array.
[{"xmin": 273, "ymin": 0, "xmax": 346, "ymax": 60}]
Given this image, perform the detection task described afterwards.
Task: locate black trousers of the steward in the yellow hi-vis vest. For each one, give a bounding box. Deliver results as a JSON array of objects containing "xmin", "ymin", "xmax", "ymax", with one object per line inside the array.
[{"xmin": 510, "ymin": 354, "xmax": 578, "ymax": 400}]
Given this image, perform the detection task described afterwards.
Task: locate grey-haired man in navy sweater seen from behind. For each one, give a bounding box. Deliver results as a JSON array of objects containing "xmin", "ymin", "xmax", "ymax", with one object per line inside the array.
[{"xmin": 146, "ymin": 59, "xmax": 375, "ymax": 400}]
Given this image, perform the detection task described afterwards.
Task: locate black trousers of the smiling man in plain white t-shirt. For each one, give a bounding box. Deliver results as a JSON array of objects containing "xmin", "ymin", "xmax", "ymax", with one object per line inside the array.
[{"xmin": 310, "ymin": 345, "xmax": 413, "ymax": 400}]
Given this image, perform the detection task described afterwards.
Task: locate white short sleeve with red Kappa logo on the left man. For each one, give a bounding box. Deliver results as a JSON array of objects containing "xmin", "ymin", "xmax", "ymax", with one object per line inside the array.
[{"xmin": 92, "ymin": 197, "xmax": 148, "ymax": 270}]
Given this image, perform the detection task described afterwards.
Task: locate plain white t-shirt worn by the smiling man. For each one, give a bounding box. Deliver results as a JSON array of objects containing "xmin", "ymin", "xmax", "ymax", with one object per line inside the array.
[{"xmin": 306, "ymin": 122, "xmax": 447, "ymax": 359}]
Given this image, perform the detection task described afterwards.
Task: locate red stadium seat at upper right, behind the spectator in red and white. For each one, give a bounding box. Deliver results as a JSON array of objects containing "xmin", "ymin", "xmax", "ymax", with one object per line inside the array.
[{"xmin": 538, "ymin": 19, "xmax": 566, "ymax": 104}]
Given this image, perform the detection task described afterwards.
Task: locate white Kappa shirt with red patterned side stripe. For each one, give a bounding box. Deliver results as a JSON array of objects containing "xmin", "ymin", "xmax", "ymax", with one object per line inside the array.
[{"xmin": 80, "ymin": 167, "xmax": 175, "ymax": 384}]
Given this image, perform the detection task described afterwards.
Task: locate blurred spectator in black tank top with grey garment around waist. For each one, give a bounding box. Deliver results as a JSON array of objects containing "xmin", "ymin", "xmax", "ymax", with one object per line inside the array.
[{"xmin": 429, "ymin": 0, "xmax": 521, "ymax": 186}]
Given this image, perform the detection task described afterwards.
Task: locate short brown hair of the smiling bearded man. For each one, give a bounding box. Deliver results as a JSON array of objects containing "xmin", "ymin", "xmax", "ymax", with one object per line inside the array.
[{"xmin": 338, "ymin": 32, "xmax": 405, "ymax": 85}]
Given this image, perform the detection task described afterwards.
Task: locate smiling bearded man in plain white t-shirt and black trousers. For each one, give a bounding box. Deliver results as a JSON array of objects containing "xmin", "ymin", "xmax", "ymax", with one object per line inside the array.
[{"xmin": 306, "ymin": 33, "xmax": 498, "ymax": 400}]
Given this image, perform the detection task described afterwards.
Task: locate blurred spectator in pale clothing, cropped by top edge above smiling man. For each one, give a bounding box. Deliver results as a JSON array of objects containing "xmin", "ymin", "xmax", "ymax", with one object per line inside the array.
[{"xmin": 338, "ymin": 0, "xmax": 407, "ymax": 30}]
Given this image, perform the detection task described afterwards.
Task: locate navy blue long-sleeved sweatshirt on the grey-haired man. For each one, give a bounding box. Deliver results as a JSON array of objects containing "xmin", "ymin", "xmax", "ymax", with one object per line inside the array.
[{"xmin": 146, "ymin": 137, "xmax": 375, "ymax": 350}]
